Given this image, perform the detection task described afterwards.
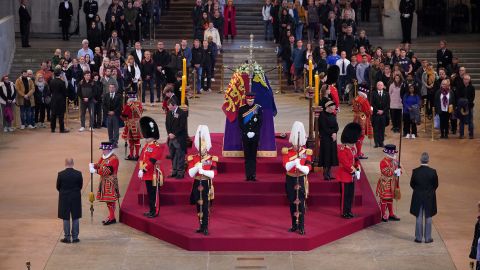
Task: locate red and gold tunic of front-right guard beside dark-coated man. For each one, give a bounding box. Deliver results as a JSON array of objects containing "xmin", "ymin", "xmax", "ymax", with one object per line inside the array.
[{"xmin": 375, "ymin": 157, "xmax": 398, "ymax": 200}]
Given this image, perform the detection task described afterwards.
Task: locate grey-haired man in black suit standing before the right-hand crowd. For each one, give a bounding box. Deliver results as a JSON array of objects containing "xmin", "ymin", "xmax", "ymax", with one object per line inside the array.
[{"xmin": 371, "ymin": 81, "xmax": 390, "ymax": 148}]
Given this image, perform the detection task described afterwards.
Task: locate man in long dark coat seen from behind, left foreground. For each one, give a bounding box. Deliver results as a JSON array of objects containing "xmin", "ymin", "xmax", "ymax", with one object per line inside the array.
[{"xmin": 57, "ymin": 158, "xmax": 83, "ymax": 243}]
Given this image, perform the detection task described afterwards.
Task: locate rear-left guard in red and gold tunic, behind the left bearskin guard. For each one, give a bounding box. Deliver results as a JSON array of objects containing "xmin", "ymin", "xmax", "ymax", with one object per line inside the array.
[{"xmin": 122, "ymin": 92, "xmax": 143, "ymax": 160}]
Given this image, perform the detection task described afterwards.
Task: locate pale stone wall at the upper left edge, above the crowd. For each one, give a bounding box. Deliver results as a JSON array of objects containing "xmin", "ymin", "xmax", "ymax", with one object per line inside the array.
[{"xmin": 0, "ymin": 16, "xmax": 15, "ymax": 76}]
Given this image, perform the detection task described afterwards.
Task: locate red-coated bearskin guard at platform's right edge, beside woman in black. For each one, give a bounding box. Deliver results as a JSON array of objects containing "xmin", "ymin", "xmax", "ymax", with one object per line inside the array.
[{"xmin": 337, "ymin": 123, "xmax": 362, "ymax": 219}]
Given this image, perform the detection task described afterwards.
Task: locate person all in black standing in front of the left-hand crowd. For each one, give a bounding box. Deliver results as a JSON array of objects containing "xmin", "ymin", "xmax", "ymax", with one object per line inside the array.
[{"xmin": 49, "ymin": 69, "xmax": 69, "ymax": 133}]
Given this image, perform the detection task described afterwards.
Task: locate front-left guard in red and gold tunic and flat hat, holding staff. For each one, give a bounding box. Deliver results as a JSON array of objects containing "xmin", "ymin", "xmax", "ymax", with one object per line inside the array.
[{"xmin": 89, "ymin": 142, "xmax": 120, "ymax": 225}]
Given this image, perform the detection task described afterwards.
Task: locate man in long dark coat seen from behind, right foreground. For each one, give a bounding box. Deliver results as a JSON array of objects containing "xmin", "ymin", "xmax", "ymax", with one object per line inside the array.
[{"xmin": 410, "ymin": 152, "xmax": 438, "ymax": 243}]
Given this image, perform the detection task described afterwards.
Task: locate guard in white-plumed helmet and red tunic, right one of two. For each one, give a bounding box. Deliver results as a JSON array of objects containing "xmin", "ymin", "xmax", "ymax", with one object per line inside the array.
[{"xmin": 282, "ymin": 121, "xmax": 313, "ymax": 235}]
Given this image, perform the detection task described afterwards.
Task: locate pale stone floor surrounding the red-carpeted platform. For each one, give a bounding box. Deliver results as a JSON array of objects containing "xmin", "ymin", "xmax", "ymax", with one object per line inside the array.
[{"xmin": 0, "ymin": 36, "xmax": 480, "ymax": 270}]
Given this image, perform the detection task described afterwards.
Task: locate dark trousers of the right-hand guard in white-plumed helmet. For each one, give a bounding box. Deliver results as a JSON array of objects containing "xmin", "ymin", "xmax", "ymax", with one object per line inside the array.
[{"xmin": 285, "ymin": 175, "xmax": 305, "ymax": 230}]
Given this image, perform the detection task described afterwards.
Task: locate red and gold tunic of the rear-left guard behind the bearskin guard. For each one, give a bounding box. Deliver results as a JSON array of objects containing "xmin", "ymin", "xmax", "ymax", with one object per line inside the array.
[{"xmin": 122, "ymin": 100, "xmax": 143, "ymax": 140}]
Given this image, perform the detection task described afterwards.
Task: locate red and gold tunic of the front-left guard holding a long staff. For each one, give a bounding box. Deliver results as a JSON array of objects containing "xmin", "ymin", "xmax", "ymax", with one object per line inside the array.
[{"xmin": 93, "ymin": 154, "xmax": 120, "ymax": 202}]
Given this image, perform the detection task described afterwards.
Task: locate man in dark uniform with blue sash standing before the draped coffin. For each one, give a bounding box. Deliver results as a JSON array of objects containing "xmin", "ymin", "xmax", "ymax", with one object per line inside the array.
[{"xmin": 238, "ymin": 92, "xmax": 262, "ymax": 181}]
